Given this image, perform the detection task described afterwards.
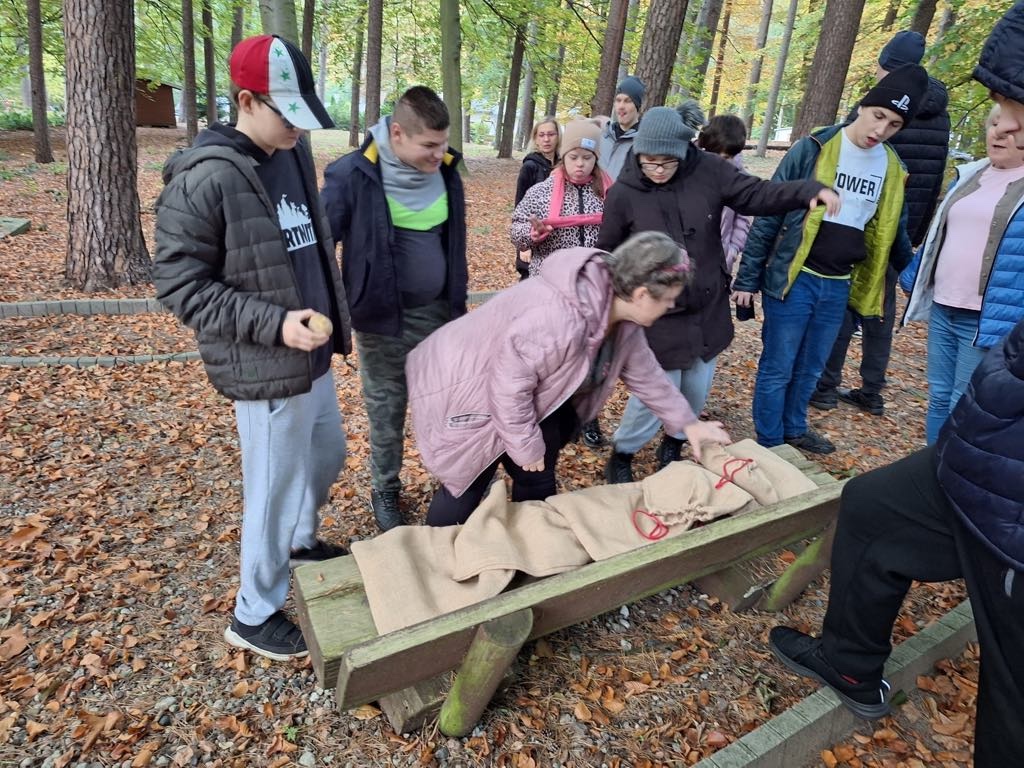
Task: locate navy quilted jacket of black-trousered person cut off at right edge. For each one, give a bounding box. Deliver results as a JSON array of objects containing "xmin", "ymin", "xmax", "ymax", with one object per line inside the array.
[{"xmin": 937, "ymin": 319, "xmax": 1024, "ymax": 571}]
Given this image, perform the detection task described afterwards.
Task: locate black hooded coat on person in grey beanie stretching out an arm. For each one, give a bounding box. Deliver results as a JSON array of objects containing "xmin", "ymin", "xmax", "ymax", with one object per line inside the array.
[{"xmin": 596, "ymin": 146, "xmax": 824, "ymax": 371}]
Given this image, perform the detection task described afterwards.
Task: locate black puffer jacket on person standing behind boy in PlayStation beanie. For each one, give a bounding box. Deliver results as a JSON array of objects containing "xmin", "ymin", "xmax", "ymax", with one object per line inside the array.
[{"xmin": 846, "ymin": 77, "xmax": 949, "ymax": 248}]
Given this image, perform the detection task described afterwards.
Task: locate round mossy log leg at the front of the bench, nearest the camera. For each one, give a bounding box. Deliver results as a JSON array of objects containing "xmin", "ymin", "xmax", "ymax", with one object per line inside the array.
[{"xmin": 437, "ymin": 608, "xmax": 534, "ymax": 736}]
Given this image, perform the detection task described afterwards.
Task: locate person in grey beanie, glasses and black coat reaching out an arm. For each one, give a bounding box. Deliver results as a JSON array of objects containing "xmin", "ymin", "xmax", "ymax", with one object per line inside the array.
[{"xmin": 597, "ymin": 106, "xmax": 839, "ymax": 482}]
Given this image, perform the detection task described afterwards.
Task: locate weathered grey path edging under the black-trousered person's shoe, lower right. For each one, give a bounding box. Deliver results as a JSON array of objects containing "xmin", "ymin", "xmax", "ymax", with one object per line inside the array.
[{"xmin": 696, "ymin": 600, "xmax": 978, "ymax": 768}]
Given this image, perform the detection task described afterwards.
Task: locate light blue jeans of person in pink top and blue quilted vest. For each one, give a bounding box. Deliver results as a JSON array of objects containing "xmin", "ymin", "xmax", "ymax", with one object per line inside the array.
[{"xmin": 925, "ymin": 304, "xmax": 988, "ymax": 445}]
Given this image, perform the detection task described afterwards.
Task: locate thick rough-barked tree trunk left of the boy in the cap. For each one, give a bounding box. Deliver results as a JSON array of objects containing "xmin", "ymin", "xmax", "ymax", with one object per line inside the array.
[{"xmin": 63, "ymin": 0, "xmax": 152, "ymax": 291}]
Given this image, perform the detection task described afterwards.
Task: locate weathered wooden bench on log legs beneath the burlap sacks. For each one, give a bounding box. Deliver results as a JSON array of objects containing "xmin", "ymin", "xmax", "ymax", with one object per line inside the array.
[{"xmin": 295, "ymin": 445, "xmax": 843, "ymax": 735}]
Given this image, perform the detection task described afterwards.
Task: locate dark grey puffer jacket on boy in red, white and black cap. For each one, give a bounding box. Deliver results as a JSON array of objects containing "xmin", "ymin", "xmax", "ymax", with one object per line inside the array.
[{"xmin": 153, "ymin": 126, "xmax": 351, "ymax": 400}]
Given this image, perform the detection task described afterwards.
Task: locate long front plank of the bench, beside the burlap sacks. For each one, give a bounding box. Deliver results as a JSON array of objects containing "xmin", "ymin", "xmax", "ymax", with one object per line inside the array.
[{"xmin": 333, "ymin": 482, "xmax": 842, "ymax": 709}]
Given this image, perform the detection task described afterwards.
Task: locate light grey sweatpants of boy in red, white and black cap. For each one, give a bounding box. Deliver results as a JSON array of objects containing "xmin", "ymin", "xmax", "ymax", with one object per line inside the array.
[{"xmin": 234, "ymin": 371, "xmax": 345, "ymax": 625}]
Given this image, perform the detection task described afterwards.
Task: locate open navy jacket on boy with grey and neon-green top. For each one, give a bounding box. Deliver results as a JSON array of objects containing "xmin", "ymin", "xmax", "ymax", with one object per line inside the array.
[{"xmin": 321, "ymin": 133, "xmax": 469, "ymax": 336}]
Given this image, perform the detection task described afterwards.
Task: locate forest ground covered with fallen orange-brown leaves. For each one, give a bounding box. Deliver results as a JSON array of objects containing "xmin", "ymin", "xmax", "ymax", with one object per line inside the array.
[{"xmin": 0, "ymin": 129, "xmax": 977, "ymax": 768}]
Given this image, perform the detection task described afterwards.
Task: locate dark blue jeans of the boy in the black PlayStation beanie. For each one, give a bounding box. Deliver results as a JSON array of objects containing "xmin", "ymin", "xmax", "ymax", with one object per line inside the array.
[{"xmin": 754, "ymin": 271, "xmax": 850, "ymax": 446}]
